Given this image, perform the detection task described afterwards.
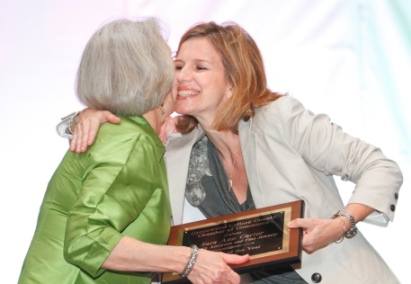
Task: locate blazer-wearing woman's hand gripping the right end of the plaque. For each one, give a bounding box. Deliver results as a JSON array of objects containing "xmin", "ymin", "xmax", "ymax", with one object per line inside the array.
[{"xmin": 287, "ymin": 218, "xmax": 345, "ymax": 253}]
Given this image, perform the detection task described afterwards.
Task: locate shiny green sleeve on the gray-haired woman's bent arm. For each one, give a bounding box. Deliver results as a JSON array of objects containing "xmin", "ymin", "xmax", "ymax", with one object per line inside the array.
[{"xmin": 64, "ymin": 135, "xmax": 160, "ymax": 277}]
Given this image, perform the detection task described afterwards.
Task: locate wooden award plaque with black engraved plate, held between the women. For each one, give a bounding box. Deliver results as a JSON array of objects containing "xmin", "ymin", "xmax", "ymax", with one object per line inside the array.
[{"xmin": 162, "ymin": 200, "xmax": 304, "ymax": 283}]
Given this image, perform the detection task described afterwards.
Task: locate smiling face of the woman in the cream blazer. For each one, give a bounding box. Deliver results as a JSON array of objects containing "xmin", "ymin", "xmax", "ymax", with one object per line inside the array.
[{"xmin": 174, "ymin": 38, "xmax": 232, "ymax": 124}]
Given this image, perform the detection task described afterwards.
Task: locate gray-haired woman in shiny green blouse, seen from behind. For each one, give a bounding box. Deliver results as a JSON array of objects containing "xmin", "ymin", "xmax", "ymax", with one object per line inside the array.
[{"xmin": 19, "ymin": 18, "xmax": 248, "ymax": 284}]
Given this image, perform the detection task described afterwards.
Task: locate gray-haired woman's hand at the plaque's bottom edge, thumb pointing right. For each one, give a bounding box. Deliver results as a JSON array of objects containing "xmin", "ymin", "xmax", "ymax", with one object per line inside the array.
[{"xmin": 187, "ymin": 249, "xmax": 249, "ymax": 284}]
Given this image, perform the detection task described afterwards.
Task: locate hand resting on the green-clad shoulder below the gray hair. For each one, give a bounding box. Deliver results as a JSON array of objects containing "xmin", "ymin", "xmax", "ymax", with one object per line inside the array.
[{"xmin": 70, "ymin": 108, "xmax": 121, "ymax": 153}]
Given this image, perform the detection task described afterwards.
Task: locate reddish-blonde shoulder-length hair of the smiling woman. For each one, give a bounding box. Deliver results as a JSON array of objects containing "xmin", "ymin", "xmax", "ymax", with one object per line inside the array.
[{"xmin": 177, "ymin": 22, "xmax": 281, "ymax": 133}]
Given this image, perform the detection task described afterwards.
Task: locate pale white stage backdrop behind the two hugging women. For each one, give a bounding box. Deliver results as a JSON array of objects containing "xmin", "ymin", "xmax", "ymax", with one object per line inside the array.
[{"xmin": 0, "ymin": 0, "xmax": 411, "ymax": 283}]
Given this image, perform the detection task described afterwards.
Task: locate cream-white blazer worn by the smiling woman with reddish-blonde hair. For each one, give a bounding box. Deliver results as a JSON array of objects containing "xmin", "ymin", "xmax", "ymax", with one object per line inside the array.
[{"xmin": 165, "ymin": 96, "xmax": 402, "ymax": 284}]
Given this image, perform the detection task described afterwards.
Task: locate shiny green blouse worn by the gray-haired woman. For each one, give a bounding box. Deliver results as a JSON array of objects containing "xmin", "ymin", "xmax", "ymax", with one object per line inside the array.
[{"xmin": 19, "ymin": 116, "xmax": 171, "ymax": 284}]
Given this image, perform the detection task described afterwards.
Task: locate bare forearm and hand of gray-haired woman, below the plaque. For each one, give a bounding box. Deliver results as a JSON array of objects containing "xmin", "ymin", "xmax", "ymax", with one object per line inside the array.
[{"xmin": 102, "ymin": 237, "xmax": 248, "ymax": 283}]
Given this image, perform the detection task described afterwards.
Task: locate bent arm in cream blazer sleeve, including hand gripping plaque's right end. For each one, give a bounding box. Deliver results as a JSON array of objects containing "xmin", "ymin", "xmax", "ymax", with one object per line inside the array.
[{"xmin": 281, "ymin": 99, "xmax": 402, "ymax": 252}]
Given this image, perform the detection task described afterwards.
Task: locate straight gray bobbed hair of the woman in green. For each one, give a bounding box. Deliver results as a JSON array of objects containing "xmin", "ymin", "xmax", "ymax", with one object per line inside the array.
[{"xmin": 76, "ymin": 18, "xmax": 174, "ymax": 115}]
